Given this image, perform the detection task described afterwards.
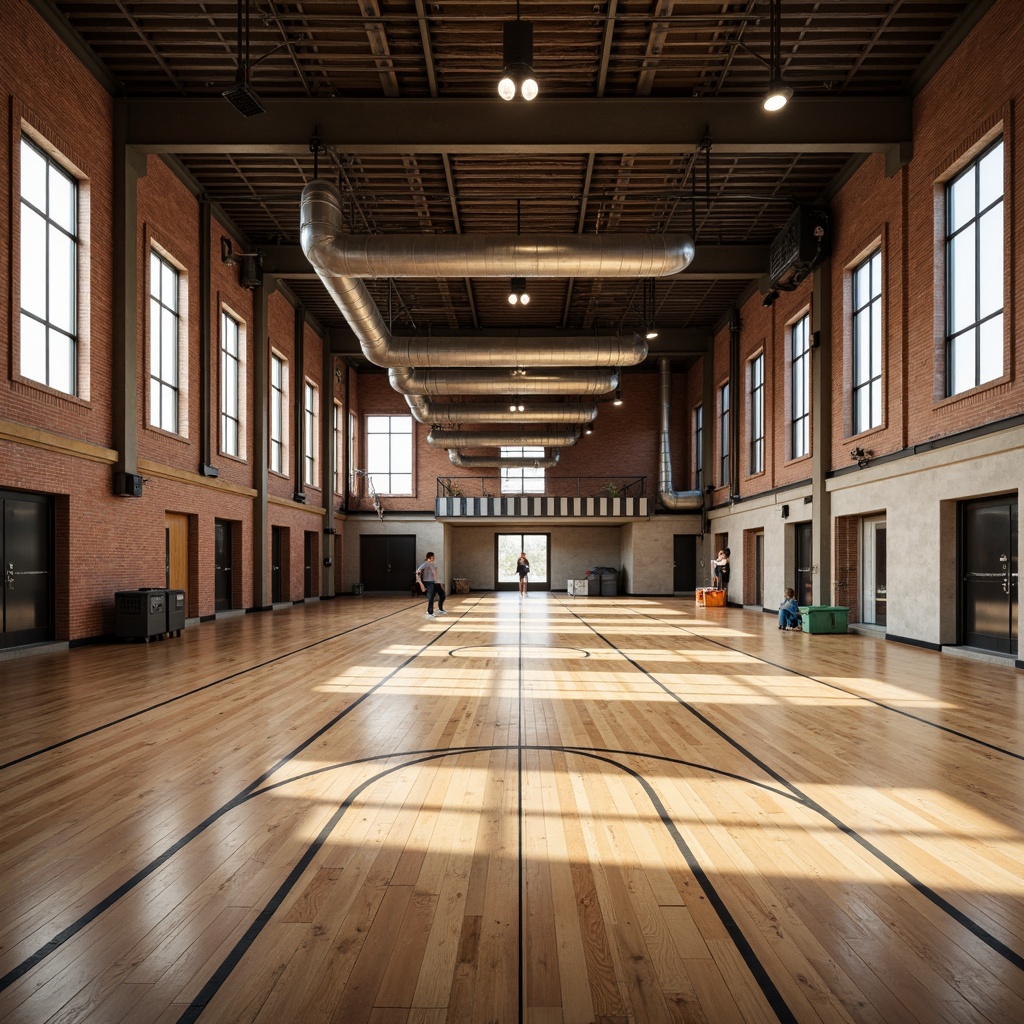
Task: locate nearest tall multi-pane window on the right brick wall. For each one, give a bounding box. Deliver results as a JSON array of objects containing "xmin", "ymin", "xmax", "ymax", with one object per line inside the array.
[{"xmin": 946, "ymin": 139, "xmax": 1004, "ymax": 394}]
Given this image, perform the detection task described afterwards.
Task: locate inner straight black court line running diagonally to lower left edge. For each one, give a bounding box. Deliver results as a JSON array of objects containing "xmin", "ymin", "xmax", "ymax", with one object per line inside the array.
[{"xmin": 0, "ymin": 602, "xmax": 479, "ymax": 992}]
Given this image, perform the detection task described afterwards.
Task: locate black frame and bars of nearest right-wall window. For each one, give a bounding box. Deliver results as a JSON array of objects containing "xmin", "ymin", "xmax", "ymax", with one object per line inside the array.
[{"xmin": 942, "ymin": 131, "xmax": 1008, "ymax": 398}]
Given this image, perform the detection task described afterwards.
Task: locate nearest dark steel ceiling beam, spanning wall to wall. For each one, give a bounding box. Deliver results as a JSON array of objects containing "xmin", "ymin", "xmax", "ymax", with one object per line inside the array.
[{"xmin": 126, "ymin": 96, "xmax": 912, "ymax": 156}]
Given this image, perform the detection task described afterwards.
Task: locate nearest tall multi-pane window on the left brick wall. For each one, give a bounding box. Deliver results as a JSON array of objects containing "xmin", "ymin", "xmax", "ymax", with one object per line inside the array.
[{"xmin": 20, "ymin": 137, "xmax": 78, "ymax": 394}]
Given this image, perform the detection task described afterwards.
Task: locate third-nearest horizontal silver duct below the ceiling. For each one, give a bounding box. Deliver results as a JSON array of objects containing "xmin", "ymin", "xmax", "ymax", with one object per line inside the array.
[{"xmin": 388, "ymin": 367, "xmax": 618, "ymax": 397}]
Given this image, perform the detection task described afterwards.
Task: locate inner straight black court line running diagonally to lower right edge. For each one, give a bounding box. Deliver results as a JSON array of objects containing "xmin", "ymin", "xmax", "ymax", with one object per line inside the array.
[{"xmin": 552, "ymin": 609, "xmax": 1024, "ymax": 971}]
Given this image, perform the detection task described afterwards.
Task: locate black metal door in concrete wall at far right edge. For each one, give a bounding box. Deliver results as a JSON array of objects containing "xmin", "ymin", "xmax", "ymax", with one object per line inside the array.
[{"xmin": 961, "ymin": 495, "xmax": 1018, "ymax": 654}]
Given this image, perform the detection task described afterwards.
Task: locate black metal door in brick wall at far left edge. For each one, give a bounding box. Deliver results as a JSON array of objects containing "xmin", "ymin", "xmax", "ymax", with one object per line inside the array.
[{"xmin": 0, "ymin": 492, "xmax": 53, "ymax": 647}]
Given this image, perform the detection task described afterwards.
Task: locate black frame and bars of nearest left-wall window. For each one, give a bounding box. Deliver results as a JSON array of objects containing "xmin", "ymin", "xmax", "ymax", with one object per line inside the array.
[{"xmin": 18, "ymin": 133, "xmax": 79, "ymax": 398}]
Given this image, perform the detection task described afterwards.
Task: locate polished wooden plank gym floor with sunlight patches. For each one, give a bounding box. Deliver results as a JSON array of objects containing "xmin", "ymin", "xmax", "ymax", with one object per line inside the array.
[{"xmin": 0, "ymin": 594, "xmax": 1024, "ymax": 1024}]
